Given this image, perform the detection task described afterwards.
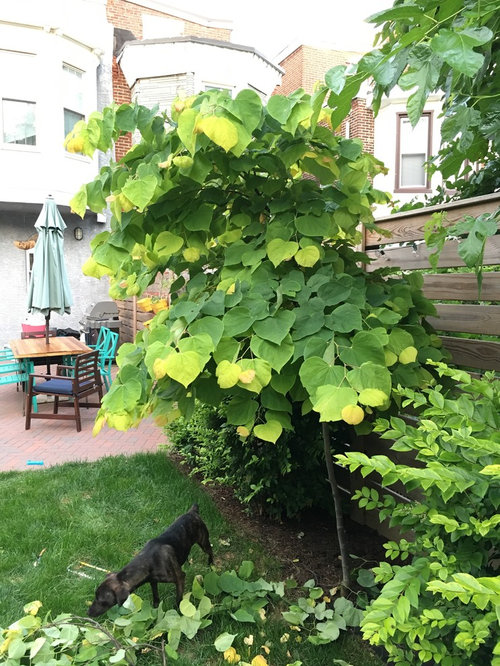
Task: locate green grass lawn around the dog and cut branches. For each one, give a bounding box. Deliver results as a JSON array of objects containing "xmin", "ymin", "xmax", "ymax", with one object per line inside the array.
[{"xmin": 0, "ymin": 453, "xmax": 382, "ymax": 666}]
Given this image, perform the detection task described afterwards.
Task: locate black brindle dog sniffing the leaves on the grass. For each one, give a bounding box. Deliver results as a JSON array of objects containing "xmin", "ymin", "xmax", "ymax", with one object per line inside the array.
[{"xmin": 88, "ymin": 504, "xmax": 213, "ymax": 617}]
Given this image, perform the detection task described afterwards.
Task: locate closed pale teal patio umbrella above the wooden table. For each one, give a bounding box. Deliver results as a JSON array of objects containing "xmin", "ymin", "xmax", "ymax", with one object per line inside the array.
[{"xmin": 28, "ymin": 197, "xmax": 73, "ymax": 344}]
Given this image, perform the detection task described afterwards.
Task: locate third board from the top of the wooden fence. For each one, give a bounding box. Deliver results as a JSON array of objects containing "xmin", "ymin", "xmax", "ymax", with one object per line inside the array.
[{"xmin": 424, "ymin": 273, "xmax": 500, "ymax": 301}]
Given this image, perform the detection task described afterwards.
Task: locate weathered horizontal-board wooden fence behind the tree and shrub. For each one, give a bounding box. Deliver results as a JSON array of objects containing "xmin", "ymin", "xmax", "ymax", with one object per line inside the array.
[{"xmin": 348, "ymin": 193, "xmax": 500, "ymax": 538}]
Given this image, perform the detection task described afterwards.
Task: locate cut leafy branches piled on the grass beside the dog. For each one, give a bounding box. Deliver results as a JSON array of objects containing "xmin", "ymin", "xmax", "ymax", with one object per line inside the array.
[{"xmin": 0, "ymin": 560, "xmax": 368, "ymax": 666}]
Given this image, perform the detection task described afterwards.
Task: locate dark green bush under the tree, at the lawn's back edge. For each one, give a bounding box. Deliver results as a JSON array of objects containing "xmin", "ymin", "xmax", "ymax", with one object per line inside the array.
[{"xmin": 167, "ymin": 403, "xmax": 331, "ymax": 517}]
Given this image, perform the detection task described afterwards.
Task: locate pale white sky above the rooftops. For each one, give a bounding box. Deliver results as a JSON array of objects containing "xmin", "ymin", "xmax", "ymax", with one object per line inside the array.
[{"xmin": 179, "ymin": 0, "xmax": 393, "ymax": 59}]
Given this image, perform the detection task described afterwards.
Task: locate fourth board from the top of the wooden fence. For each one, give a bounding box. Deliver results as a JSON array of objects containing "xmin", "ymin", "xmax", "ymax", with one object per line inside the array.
[{"xmin": 426, "ymin": 303, "xmax": 500, "ymax": 335}]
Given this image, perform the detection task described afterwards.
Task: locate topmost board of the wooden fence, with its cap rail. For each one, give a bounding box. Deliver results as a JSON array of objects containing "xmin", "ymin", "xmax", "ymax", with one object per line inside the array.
[{"xmin": 365, "ymin": 192, "xmax": 500, "ymax": 248}]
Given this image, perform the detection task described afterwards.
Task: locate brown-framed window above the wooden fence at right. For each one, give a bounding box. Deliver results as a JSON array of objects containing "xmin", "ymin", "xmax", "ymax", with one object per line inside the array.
[{"xmin": 395, "ymin": 111, "xmax": 432, "ymax": 192}]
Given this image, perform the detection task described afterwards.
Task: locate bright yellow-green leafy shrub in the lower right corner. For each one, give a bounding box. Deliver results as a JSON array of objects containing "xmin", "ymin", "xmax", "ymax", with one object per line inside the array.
[{"xmin": 337, "ymin": 364, "xmax": 500, "ymax": 666}]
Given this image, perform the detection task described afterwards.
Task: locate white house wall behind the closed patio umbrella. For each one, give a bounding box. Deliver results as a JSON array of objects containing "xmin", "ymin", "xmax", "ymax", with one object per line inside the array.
[{"xmin": 0, "ymin": 0, "xmax": 113, "ymax": 345}]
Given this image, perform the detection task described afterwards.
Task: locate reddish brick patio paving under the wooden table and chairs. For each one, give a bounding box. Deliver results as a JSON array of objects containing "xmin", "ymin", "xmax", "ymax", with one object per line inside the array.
[{"xmin": 0, "ymin": 374, "xmax": 166, "ymax": 472}]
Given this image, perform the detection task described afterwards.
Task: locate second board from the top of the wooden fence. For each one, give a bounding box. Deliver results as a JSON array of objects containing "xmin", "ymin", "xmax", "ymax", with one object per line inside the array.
[{"xmin": 366, "ymin": 236, "xmax": 500, "ymax": 272}]
